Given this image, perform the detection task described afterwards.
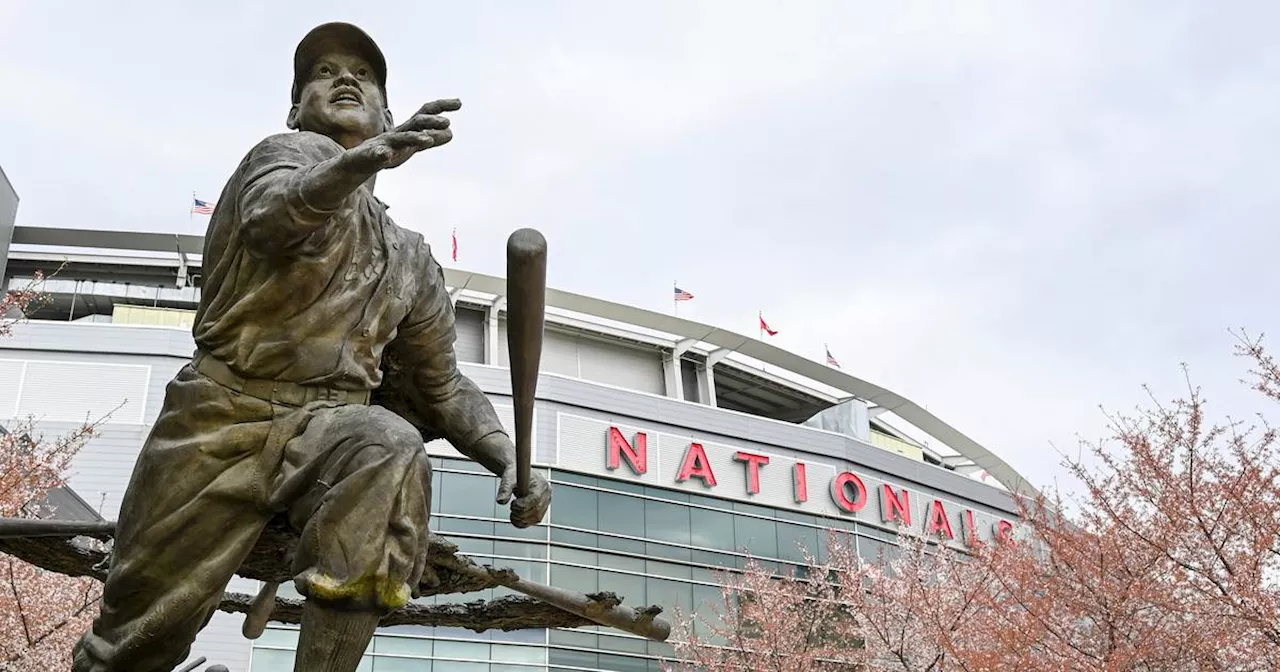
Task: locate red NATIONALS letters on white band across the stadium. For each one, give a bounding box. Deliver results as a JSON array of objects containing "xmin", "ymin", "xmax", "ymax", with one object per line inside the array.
[{"xmin": 557, "ymin": 413, "xmax": 1014, "ymax": 545}]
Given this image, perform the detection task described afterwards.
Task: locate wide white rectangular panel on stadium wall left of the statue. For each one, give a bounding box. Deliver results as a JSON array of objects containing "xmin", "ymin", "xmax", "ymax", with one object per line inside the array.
[{"xmin": 18, "ymin": 361, "xmax": 151, "ymax": 424}]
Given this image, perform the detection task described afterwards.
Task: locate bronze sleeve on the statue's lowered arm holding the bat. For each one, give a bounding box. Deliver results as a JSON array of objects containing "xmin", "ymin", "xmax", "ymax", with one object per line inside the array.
[{"xmin": 388, "ymin": 236, "xmax": 503, "ymax": 454}]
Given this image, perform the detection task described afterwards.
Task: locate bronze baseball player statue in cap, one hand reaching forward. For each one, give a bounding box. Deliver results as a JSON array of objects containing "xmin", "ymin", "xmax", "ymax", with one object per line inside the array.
[{"xmin": 74, "ymin": 23, "xmax": 550, "ymax": 672}]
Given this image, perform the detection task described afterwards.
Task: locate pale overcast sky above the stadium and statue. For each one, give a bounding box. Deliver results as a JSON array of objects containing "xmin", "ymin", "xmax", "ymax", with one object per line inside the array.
[{"xmin": 0, "ymin": 0, "xmax": 1280, "ymax": 485}]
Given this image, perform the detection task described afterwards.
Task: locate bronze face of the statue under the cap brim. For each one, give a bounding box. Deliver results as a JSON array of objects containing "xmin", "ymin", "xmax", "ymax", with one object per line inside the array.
[{"xmin": 289, "ymin": 52, "xmax": 389, "ymax": 148}]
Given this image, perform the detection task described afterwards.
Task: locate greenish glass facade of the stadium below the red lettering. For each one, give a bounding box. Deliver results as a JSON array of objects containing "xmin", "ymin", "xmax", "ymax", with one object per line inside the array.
[{"xmin": 251, "ymin": 457, "xmax": 911, "ymax": 672}]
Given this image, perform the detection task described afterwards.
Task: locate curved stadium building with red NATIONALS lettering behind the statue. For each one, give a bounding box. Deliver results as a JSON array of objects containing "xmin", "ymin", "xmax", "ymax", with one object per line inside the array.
[{"xmin": 0, "ymin": 174, "xmax": 1021, "ymax": 672}]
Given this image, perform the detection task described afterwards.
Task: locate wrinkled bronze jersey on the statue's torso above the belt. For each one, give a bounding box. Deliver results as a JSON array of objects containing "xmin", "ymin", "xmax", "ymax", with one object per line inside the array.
[{"xmin": 193, "ymin": 132, "xmax": 454, "ymax": 390}]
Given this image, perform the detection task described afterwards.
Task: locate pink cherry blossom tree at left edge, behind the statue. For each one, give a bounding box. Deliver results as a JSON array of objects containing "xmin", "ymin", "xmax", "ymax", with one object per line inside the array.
[{"xmin": 0, "ymin": 275, "xmax": 101, "ymax": 669}]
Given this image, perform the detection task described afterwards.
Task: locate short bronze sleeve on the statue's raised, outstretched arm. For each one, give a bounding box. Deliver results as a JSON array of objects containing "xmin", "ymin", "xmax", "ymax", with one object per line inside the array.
[{"xmin": 237, "ymin": 132, "xmax": 342, "ymax": 256}]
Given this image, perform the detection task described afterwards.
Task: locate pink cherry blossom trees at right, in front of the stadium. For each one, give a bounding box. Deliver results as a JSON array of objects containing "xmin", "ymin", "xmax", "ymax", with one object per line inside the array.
[{"xmin": 669, "ymin": 335, "xmax": 1280, "ymax": 672}]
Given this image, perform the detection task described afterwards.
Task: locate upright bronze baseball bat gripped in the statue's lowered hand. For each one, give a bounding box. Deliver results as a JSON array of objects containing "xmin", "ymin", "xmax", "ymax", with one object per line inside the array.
[{"xmin": 507, "ymin": 229, "xmax": 547, "ymax": 497}]
